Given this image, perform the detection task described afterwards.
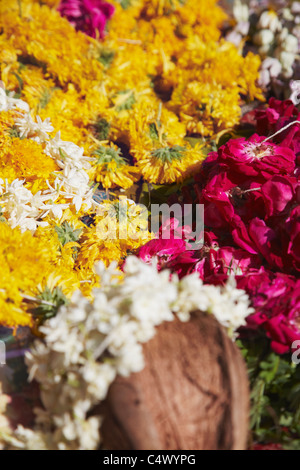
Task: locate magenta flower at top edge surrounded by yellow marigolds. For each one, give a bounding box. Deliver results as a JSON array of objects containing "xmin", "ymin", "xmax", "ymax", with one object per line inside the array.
[{"xmin": 58, "ymin": 0, "xmax": 115, "ymax": 38}]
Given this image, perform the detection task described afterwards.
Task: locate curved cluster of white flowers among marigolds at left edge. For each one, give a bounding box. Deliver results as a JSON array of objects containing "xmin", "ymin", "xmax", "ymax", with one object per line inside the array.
[{"xmin": 0, "ymin": 88, "xmax": 98, "ymax": 232}]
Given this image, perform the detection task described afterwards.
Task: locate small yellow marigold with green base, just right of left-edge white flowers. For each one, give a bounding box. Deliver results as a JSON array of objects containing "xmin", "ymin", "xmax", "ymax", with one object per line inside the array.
[{"xmin": 90, "ymin": 144, "xmax": 140, "ymax": 189}]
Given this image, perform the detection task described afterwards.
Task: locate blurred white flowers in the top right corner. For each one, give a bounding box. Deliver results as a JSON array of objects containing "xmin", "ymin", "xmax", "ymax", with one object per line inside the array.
[{"xmin": 226, "ymin": 0, "xmax": 300, "ymax": 87}]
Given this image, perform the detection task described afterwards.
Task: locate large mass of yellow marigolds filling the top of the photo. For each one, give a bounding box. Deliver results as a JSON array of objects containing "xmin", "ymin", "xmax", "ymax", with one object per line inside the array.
[{"xmin": 0, "ymin": 0, "xmax": 263, "ymax": 189}]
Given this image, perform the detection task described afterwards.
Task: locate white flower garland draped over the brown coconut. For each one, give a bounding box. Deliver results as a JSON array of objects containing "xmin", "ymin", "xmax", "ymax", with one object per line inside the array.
[{"xmin": 4, "ymin": 256, "xmax": 253, "ymax": 449}]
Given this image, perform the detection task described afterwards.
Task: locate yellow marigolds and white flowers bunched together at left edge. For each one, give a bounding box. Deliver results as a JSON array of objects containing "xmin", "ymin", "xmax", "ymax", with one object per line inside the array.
[{"xmin": 0, "ymin": 88, "xmax": 152, "ymax": 328}]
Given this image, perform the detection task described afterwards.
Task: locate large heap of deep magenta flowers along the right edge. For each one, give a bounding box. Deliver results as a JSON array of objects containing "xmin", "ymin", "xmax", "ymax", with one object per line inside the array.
[{"xmin": 140, "ymin": 99, "xmax": 300, "ymax": 354}]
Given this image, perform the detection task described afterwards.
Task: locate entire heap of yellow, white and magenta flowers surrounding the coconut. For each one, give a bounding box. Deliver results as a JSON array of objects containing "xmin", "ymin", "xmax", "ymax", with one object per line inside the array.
[{"xmin": 0, "ymin": 0, "xmax": 300, "ymax": 450}]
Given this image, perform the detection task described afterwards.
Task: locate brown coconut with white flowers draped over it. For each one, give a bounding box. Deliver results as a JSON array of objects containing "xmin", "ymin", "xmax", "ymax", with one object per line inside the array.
[{"xmin": 101, "ymin": 312, "xmax": 249, "ymax": 450}]
